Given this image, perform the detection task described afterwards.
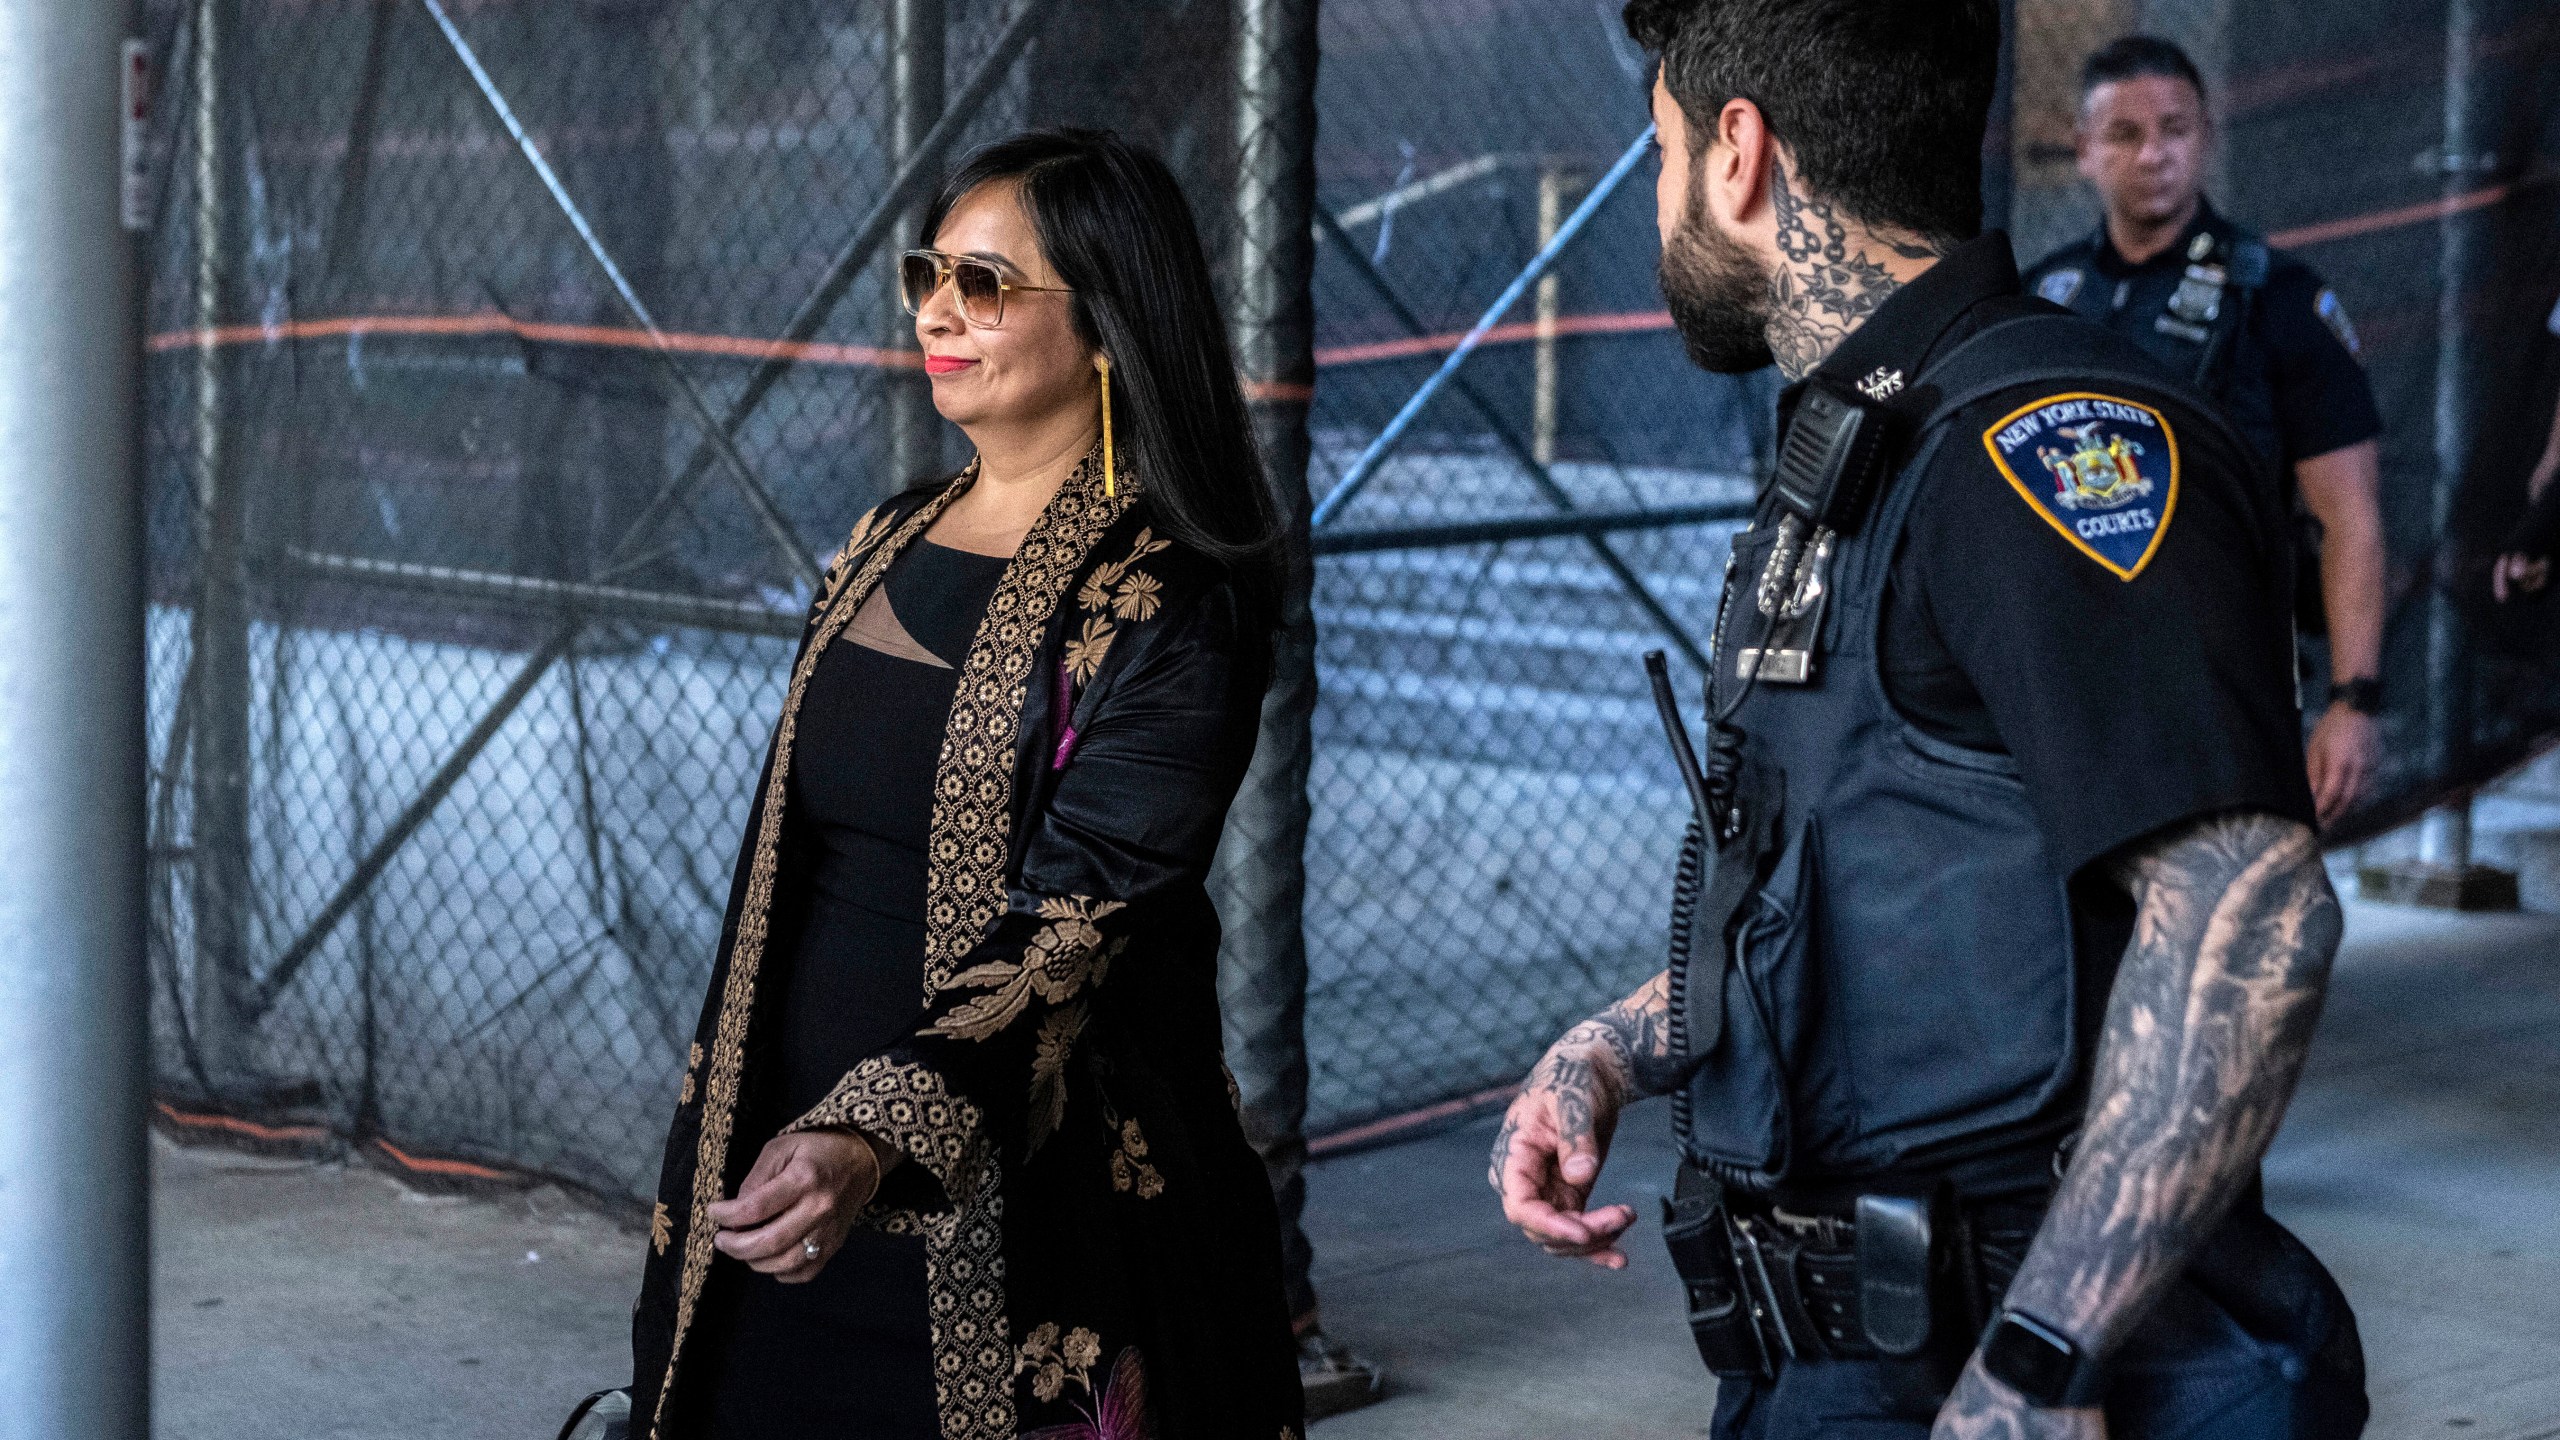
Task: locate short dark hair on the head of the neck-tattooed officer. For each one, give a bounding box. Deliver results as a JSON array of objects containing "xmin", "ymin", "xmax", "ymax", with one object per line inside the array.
[{"xmin": 1626, "ymin": 0, "xmax": 1999, "ymax": 243}]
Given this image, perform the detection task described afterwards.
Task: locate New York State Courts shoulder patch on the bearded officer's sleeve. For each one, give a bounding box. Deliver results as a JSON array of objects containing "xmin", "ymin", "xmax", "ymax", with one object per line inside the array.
[{"xmin": 1981, "ymin": 392, "xmax": 2179, "ymax": 579}]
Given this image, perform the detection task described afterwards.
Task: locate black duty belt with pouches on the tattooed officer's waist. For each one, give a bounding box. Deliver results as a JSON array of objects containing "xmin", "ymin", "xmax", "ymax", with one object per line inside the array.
[{"xmin": 1661, "ymin": 1166, "xmax": 2040, "ymax": 1379}]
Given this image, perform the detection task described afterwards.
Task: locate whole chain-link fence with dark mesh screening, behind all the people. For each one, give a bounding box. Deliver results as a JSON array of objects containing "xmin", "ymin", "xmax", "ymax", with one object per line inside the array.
[{"xmin": 148, "ymin": 0, "xmax": 2560, "ymax": 1197}]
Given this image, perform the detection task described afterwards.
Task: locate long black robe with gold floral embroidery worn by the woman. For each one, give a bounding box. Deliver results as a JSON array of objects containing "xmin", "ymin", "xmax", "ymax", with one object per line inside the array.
[{"xmin": 632, "ymin": 461, "xmax": 1303, "ymax": 1440}]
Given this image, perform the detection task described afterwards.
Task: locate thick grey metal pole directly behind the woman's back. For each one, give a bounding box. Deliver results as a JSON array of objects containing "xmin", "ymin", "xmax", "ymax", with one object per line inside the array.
[{"xmin": 1211, "ymin": 0, "xmax": 1316, "ymax": 1314}]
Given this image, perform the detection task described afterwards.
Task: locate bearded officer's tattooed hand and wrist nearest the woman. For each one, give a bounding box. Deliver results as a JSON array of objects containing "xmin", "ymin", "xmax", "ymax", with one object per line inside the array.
[{"xmin": 1485, "ymin": 974, "xmax": 1679, "ymax": 1271}]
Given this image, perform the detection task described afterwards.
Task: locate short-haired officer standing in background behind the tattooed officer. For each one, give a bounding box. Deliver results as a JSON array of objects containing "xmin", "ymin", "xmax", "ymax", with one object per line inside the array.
[{"xmin": 2028, "ymin": 36, "xmax": 2383, "ymax": 822}]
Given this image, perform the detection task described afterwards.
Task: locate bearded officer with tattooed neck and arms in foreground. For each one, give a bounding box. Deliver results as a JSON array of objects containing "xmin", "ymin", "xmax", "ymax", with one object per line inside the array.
[{"xmin": 1490, "ymin": 0, "xmax": 2365, "ymax": 1440}]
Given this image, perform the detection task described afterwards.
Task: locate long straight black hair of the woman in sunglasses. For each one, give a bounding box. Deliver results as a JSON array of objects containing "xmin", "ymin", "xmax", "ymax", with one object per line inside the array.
[{"xmin": 916, "ymin": 128, "xmax": 1285, "ymax": 628}]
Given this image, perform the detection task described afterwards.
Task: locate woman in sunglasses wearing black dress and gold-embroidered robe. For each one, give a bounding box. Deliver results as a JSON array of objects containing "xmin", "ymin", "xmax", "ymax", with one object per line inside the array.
[{"xmin": 632, "ymin": 131, "xmax": 1303, "ymax": 1440}]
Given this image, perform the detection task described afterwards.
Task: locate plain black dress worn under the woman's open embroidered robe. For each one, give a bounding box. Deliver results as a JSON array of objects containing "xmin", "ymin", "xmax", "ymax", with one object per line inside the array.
[{"xmin": 694, "ymin": 541, "xmax": 1006, "ymax": 1440}]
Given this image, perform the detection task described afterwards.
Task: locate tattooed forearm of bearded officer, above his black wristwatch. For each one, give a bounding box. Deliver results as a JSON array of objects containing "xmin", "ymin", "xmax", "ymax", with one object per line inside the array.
[{"xmin": 2010, "ymin": 815, "xmax": 2340, "ymax": 1353}]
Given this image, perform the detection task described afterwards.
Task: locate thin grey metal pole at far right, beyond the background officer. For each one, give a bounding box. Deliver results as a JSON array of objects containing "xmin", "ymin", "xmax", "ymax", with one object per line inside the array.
[{"xmin": 2419, "ymin": 0, "xmax": 2488, "ymax": 869}]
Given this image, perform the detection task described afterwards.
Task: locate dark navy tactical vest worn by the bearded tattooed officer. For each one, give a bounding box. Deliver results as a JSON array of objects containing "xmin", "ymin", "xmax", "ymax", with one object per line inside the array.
[{"xmin": 1672, "ymin": 315, "xmax": 2243, "ymax": 1189}]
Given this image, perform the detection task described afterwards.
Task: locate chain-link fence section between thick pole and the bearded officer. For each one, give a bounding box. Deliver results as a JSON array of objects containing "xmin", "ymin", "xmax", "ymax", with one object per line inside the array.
[{"xmin": 1306, "ymin": 3, "xmax": 1774, "ymax": 1130}]
